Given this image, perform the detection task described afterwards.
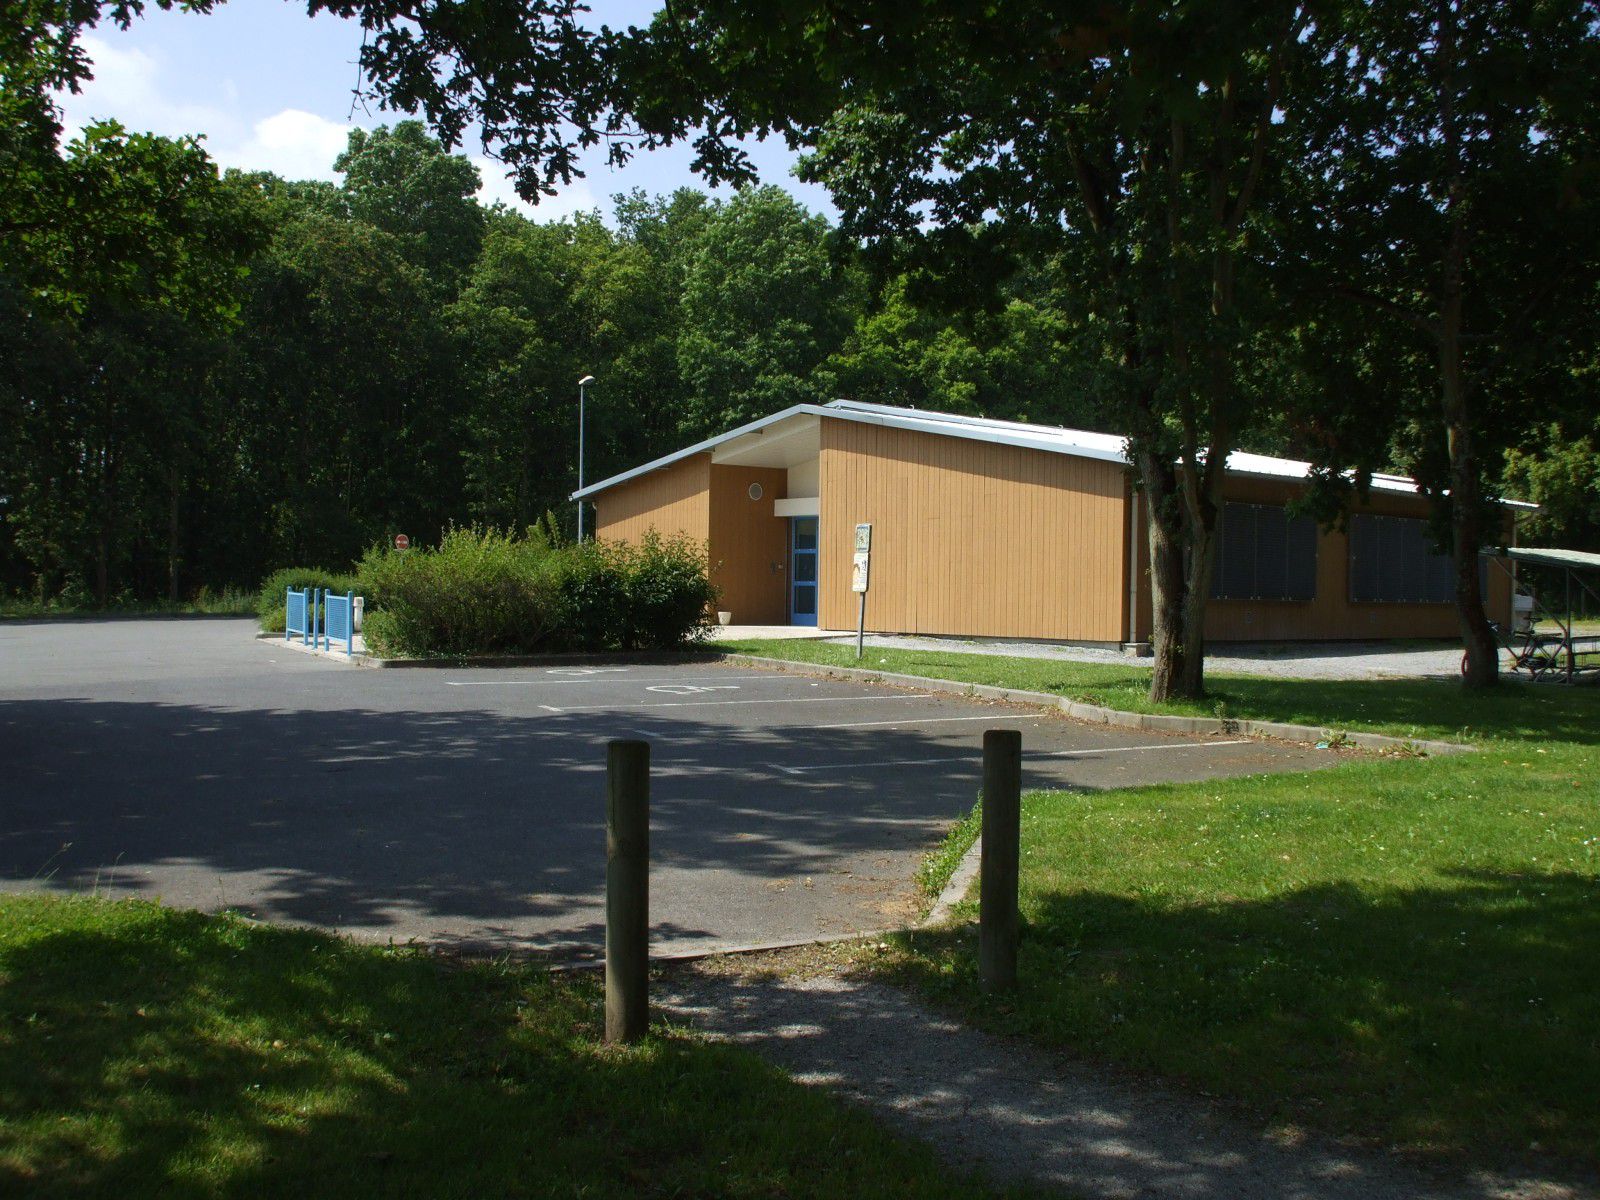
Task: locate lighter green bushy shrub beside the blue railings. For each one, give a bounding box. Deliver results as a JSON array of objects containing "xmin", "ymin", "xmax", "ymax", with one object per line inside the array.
[{"xmin": 357, "ymin": 528, "xmax": 566, "ymax": 658}]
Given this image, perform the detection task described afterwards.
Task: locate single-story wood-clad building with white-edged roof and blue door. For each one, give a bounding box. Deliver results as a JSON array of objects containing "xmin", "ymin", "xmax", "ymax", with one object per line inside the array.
[{"xmin": 574, "ymin": 400, "xmax": 1510, "ymax": 645}]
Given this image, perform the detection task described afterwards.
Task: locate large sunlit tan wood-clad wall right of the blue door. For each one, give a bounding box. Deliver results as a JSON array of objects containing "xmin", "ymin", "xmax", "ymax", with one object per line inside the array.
[{"xmin": 819, "ymin": 418, "xmax": 1126, "ymax": 642}]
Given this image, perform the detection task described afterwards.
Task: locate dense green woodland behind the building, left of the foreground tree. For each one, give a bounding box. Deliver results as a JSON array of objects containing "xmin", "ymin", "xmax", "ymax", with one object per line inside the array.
[{"xmin": 0, "ymin": 122, "xmax": 1126, "ymax": 611}]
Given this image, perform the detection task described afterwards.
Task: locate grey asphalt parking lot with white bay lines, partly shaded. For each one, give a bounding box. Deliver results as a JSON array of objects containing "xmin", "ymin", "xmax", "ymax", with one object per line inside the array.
[{"xmin": 0, "ymin": 619, "xmax": 1334, "ymax": 950}]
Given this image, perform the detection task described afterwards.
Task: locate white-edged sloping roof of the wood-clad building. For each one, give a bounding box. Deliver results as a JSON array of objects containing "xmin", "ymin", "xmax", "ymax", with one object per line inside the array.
[{"xmin": 571, "ymin": 400, "xmax": 1534, "ymax": 507}]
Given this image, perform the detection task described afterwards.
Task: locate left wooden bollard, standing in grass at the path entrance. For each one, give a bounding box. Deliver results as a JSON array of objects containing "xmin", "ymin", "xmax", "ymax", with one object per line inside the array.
[{"xmin": 605, "ymin": 741, "xmax": 650, "ymax": 1042}]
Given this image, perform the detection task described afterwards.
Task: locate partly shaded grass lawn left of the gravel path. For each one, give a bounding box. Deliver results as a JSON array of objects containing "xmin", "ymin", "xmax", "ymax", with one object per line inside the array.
[{"xmin": 0, "ymin": 896, "xmax": 1024, "ymax": 1200}]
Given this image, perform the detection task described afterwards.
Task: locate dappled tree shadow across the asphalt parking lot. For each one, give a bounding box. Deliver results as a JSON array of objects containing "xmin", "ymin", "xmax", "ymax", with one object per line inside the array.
[{"xmin": 0, "ymin": 699, "xmax": 1113, "ymax": 947}]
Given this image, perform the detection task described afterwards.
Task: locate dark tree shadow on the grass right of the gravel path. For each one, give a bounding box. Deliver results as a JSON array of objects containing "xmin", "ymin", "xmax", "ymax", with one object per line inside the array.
[{"xmin": 885, "ymin": 870, "xmax": 1600, "ymax": 1184}]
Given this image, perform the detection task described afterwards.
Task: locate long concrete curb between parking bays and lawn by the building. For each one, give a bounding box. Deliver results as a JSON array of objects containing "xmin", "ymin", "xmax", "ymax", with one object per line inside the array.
[{"xmin": 720, "ymin": 653, "xmax": 1477, "ymax": 754}]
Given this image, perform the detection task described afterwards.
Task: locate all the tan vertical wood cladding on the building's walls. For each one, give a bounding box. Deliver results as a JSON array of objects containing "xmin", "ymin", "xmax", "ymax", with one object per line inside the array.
[{"xmin": 594, "ymin": 418, "xmax": 1510, "ymax": 642}]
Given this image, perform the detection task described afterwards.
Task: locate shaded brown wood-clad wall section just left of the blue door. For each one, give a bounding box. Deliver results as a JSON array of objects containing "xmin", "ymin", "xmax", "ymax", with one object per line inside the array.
[{"xmin": 710, "ymin": 464, "xmax": 789, "ymax": 626}]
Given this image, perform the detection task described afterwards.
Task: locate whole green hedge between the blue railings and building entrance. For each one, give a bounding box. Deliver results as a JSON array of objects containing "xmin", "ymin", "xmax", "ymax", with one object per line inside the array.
[{"xmin": 355, "ymin": 528, "xmax": 717, "ymax": 658}]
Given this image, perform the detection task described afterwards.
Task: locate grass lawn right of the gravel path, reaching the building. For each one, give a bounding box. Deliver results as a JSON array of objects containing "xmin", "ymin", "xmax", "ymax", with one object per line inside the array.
[{"xmin": 732, "ymin": 643, "xmax": 1600, "ymax": 1171}]
